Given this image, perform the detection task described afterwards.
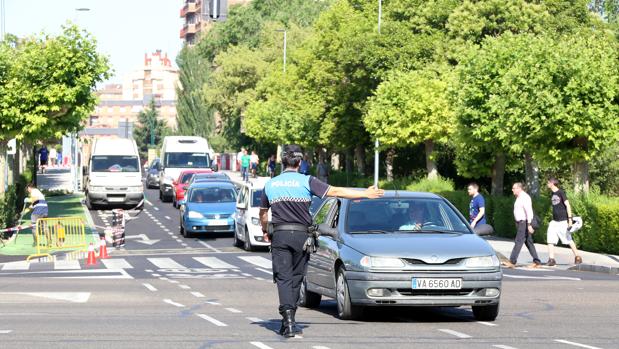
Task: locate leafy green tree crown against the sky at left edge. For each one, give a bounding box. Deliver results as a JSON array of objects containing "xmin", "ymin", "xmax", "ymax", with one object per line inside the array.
[{"xmin": 0, "ymin": 26, "xmax": 109, "ymax": 140}]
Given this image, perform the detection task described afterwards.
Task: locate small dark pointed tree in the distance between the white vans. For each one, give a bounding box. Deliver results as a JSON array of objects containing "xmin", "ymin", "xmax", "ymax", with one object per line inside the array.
[{"xmin": 133, "ymin": 99, "xmax": 171, "ymax": 159}]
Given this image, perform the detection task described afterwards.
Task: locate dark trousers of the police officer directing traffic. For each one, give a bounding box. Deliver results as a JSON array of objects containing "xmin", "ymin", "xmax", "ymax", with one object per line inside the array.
[{"xmin": 271, "ymin": 230, "xmax": 309, "ymax": 313}]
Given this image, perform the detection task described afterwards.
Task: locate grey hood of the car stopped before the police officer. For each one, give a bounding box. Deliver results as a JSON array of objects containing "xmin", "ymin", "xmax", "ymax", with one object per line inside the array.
[{"xmin": 344, "ymin": 233, "xmax": 494, "ymax": 263}]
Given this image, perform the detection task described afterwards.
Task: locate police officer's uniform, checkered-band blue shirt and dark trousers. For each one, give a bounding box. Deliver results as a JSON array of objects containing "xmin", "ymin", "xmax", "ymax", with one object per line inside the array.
[{"xmin": 261, "ymin": 170, "xmax": 329, "ymax": 313}]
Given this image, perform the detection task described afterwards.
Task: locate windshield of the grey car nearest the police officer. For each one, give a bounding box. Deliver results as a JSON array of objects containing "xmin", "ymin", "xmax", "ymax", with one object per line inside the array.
[{"xmin": 346, "ymin": 198, "xmax": 470, "ymax": 234}]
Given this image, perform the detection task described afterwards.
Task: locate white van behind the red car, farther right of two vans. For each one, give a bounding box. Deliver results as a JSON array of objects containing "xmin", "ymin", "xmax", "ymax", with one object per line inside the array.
[{"xmin": 159, "ymin": 136, "xmax": 214, "ymax": 201}]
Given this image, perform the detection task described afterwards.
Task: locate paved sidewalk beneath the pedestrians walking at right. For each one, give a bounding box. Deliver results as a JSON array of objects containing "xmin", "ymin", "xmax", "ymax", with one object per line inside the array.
[{"xmin": 485, "ymin": 236, "xmax": 619, "ymax": 274}]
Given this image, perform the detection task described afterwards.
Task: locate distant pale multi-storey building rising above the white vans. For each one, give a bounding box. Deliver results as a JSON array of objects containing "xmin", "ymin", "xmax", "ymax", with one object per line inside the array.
[{"xmin": 87, "ymin": 50, "xmax": 179, "ymax": 129}]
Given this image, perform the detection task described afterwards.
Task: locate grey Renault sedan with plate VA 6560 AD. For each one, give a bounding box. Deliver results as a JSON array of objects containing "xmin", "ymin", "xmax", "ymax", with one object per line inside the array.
[{"xmin": 301, "ymin": 191, "xmax": 503, "ymax": 321}]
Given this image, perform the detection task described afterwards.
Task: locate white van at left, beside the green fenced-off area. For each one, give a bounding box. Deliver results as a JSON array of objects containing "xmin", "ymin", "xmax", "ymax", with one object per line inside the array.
[{"xmin": 85, "ymin": 138, "xmax": 144, "ymax": 209}]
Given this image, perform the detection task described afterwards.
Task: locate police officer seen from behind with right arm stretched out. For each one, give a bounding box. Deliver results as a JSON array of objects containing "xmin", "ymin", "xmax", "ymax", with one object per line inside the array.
[{"xmin": 260, "ymin": 145, "xmax": 384, "ymax": 337}]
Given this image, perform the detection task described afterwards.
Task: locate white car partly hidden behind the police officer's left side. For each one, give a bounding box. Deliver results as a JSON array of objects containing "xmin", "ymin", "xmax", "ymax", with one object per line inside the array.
[{"xmin": 234, "ymin": 180, "xmax": 271, "ymax": 251}]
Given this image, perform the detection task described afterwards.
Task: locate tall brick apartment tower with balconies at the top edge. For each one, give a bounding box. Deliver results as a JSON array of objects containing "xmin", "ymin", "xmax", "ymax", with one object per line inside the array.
[{"xmin": 180, "ymin": 0, "xmax": 251, "ymax": 45}]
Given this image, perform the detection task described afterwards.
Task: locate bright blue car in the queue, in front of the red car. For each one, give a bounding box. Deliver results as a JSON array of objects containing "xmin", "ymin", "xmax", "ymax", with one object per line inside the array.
[{"xmin": 180, "ymin": 181, "xmax": 236, "ymax": 238}]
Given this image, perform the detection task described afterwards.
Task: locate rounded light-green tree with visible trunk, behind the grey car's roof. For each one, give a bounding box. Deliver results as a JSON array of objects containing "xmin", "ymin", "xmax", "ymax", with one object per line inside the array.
[{"xmin": 364, "ymin": 68, "xmax": 455, "ymax": 179}]
